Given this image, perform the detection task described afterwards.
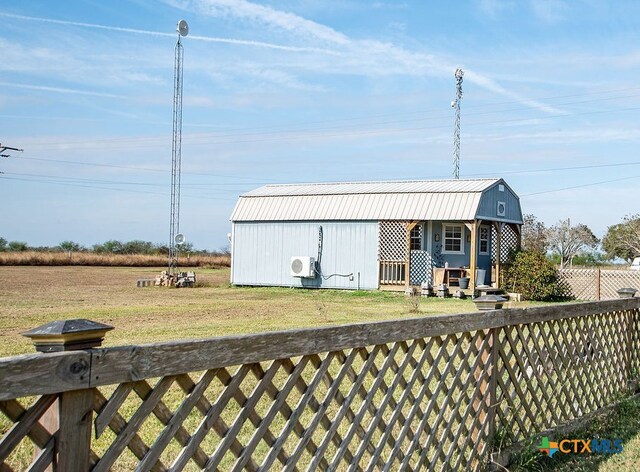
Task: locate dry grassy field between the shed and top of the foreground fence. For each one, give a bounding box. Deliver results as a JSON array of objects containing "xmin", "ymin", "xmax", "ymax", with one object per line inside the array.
[{"xmin": 0, "ymin": 266, "xmax": 496, "ymax": 357}]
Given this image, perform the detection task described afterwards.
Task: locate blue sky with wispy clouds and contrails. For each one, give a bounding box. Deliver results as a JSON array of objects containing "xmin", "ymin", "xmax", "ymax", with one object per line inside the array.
[{"xmin": 0, "ymin": 0, "xmax": 640, "ymax": 249}]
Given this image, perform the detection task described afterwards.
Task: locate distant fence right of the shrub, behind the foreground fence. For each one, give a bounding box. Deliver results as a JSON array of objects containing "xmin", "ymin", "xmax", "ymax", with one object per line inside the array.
[{"xmin": 560, "ymin": 268, "xmax": 640, "ymax": 300}]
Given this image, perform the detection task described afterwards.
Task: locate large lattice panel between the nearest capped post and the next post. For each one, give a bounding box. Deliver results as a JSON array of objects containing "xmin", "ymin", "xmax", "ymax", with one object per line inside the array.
[{"xmin": 84, "ymin": 331, "xmax": 491, "ymax": 471}]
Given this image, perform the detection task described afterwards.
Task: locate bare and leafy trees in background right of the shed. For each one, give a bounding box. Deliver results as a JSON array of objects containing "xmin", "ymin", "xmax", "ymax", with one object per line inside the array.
[{"xmin": 522, "ymin": 214, "xmax": 640, "ymax": 268}]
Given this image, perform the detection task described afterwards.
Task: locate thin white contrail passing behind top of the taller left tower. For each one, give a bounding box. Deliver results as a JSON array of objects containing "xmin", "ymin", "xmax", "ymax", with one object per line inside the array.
[{"xmin": 0, "ymin": 12, "xmax": 340, "ymax": 56}]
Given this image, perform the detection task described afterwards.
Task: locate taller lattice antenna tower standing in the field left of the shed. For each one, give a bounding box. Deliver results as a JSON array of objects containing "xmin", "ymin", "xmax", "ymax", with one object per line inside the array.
[{"xmin": 169, "ymin": 20, "xmax": 189, "ymax": 275}]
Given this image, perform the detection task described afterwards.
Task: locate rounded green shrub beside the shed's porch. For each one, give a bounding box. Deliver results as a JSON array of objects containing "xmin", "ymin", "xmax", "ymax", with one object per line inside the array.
[{"xmin": 504, "ymin": 251, "xmax": 571, "ymax": 301}]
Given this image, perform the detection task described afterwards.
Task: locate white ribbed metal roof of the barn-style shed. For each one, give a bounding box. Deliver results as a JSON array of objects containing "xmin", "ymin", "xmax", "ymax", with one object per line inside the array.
[{"xmin": 231, "ymin": 179, "xmax": 503, "ymax": 221}]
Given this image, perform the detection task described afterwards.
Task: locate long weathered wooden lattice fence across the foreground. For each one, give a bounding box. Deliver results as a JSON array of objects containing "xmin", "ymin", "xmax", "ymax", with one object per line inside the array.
[{"xmin": 0, "ymin": 298, "xmax": 640, "ymax": 471}]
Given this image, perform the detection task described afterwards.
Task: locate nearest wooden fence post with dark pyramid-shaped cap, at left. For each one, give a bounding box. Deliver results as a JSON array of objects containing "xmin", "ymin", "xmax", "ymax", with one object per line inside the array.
[{"xmin": 23, "ymin": 319, "xmax": 113, "ymax": 472}]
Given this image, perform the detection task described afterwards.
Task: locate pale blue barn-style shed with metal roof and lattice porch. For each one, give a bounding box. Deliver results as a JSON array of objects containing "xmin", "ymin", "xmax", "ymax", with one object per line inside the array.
[{"xmin": 231, "ymin": 179, "xmax": 522, "ymax": 289}]
